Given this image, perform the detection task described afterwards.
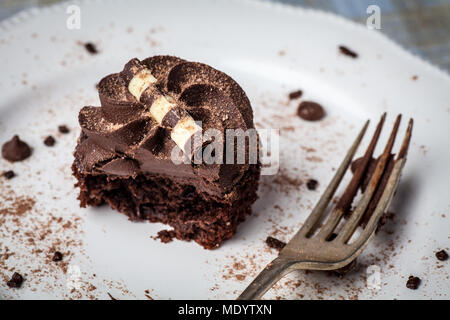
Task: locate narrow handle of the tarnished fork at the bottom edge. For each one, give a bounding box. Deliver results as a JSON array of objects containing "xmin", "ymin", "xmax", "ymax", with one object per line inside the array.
[{"xmin": 237, "ymin": 258, "xmax": 296, "ymax": 300}]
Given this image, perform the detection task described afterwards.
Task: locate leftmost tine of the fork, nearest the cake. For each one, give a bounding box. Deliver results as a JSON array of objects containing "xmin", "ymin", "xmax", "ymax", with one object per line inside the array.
[{"xmin": 294, "ymin": 120, "xmax": 370, "ymax": 238}]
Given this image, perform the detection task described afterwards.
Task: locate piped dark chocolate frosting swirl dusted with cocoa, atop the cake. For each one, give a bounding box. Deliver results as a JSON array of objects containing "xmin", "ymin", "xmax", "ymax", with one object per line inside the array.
[{"xmin": 75, "ymin": 56, "xmax": 254, "ymax": 194}]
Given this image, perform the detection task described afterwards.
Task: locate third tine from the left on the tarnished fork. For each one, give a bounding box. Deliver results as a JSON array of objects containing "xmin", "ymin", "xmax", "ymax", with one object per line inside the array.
[{"xmin": 336, "ymin": 115, "xmax": 401, "ymax": 243}]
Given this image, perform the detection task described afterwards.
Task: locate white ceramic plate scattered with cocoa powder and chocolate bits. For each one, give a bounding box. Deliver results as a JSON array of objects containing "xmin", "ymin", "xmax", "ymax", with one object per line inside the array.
[{"xmin": 0, "ymin": 0, "xmax": 450, "ymax": 299}]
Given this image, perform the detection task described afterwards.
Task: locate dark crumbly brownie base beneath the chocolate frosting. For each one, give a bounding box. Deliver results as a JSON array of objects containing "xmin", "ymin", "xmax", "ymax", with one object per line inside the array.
[{"xmin": 72, "ymin": 161, "xmax": 260, "ymax": 249}]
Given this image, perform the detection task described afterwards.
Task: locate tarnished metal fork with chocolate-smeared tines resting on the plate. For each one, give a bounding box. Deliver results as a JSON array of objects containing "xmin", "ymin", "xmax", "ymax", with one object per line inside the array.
[{"xmin": 238, "ymin": 113, "xmax": 413, "ymax": 300}]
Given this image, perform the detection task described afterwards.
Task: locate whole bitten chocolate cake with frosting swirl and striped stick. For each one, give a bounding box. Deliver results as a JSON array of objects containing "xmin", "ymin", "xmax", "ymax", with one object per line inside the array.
[{"xmin": 72, "ymin": 56, "xmax": 260, "ymax": 249}]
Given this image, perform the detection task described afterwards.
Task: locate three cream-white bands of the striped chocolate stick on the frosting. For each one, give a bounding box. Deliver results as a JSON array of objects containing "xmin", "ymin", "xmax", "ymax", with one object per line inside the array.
[{"xmin": 128, "ymin": 63, "xmax": 202, "ymax": 159}]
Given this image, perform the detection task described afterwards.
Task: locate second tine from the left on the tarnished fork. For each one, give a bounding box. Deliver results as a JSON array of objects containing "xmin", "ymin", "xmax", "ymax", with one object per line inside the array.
[{"xmin": 317, "ymin": 113, "xmax": 386, "ymax": 240}]
